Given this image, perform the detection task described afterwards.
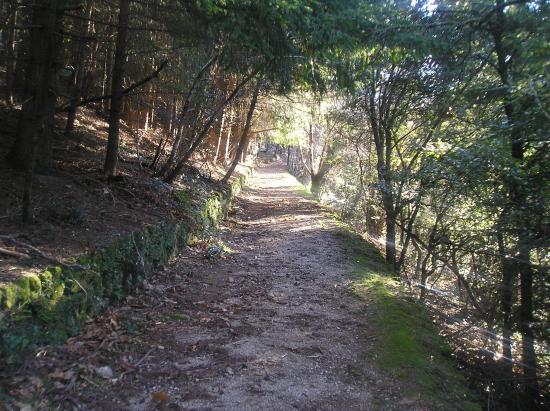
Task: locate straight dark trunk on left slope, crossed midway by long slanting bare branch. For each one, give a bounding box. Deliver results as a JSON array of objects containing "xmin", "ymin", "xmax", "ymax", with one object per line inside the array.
[{"xmin": 103, "ymin": 0, "xmax": 130, "ymax": 177}]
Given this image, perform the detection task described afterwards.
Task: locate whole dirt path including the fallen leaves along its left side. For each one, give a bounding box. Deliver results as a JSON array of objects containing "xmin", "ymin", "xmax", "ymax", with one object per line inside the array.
[{"xmin": 0, "ymin": 163, "xmax": 478, "ymax": 410}]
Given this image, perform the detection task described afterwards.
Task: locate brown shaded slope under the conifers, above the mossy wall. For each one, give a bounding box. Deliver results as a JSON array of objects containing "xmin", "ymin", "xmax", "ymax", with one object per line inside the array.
[{"xmin": 0, "ymin": 109, "xmax": 231, "ymax": 283}]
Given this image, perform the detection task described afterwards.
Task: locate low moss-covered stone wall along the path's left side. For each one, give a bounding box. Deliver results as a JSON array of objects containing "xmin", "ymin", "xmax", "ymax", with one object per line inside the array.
[{"xmin": 0, "ymin": 171, "xmax": 250, "ymax": 366}]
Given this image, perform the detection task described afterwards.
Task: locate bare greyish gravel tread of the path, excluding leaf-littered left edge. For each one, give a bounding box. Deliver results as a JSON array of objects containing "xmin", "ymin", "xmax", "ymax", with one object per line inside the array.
[{"xmin": 105, "ymin": 164, "xmax": 398, "ymax": 410}]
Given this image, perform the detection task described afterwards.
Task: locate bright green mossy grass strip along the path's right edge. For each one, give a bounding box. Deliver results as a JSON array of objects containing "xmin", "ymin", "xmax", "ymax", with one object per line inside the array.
[{"xmin": 339, "ymin": 226, "xmax": 481, "ymax": 410}]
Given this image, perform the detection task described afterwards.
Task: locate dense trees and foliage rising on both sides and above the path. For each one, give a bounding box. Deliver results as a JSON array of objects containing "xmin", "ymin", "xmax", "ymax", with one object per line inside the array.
[{"xmin": 0, "ymin": 0, "xmax": 550, "ymax": 410}]
